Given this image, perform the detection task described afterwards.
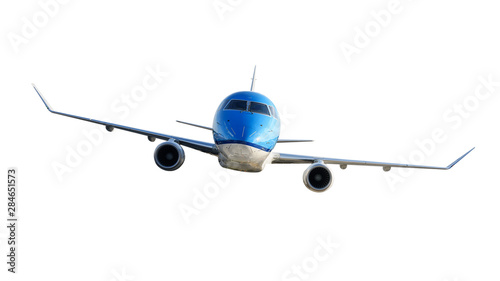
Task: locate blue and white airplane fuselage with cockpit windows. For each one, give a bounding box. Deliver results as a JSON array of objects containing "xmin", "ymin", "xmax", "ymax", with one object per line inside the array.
[{"xmin": 212, "ymin": 91, "xmax": 280, "ymax": 172}]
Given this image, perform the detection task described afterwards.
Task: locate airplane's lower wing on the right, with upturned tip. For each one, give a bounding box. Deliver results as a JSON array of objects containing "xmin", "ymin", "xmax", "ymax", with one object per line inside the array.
[{"xmin": 271, "ymin": 148, "xmax": 474, "ymax": 172}]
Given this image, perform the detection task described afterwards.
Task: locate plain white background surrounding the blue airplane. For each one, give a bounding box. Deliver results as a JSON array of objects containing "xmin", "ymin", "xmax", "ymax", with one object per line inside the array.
[{"xmin": 0, "ymin": 0, "xmax": 500, "ymax": 281}]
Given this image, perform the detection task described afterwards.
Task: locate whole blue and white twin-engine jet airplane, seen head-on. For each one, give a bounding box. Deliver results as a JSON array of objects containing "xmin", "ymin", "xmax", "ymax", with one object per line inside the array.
[{"xmin": 32, "ymin": 67, "xmax": 474, "ymax": 192}]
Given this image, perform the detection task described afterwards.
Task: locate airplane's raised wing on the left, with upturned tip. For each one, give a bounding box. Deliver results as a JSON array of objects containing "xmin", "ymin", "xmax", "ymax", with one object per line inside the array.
[{"xmin": 32, "ymin": 84, "xmax": 219, "ymax": 155}]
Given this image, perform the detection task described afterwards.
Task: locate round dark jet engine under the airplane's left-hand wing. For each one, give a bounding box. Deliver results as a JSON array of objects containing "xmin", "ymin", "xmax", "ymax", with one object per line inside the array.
[{"xmin": 154, "ymin": 141, "xmax": 185, "ymax": 171}]
